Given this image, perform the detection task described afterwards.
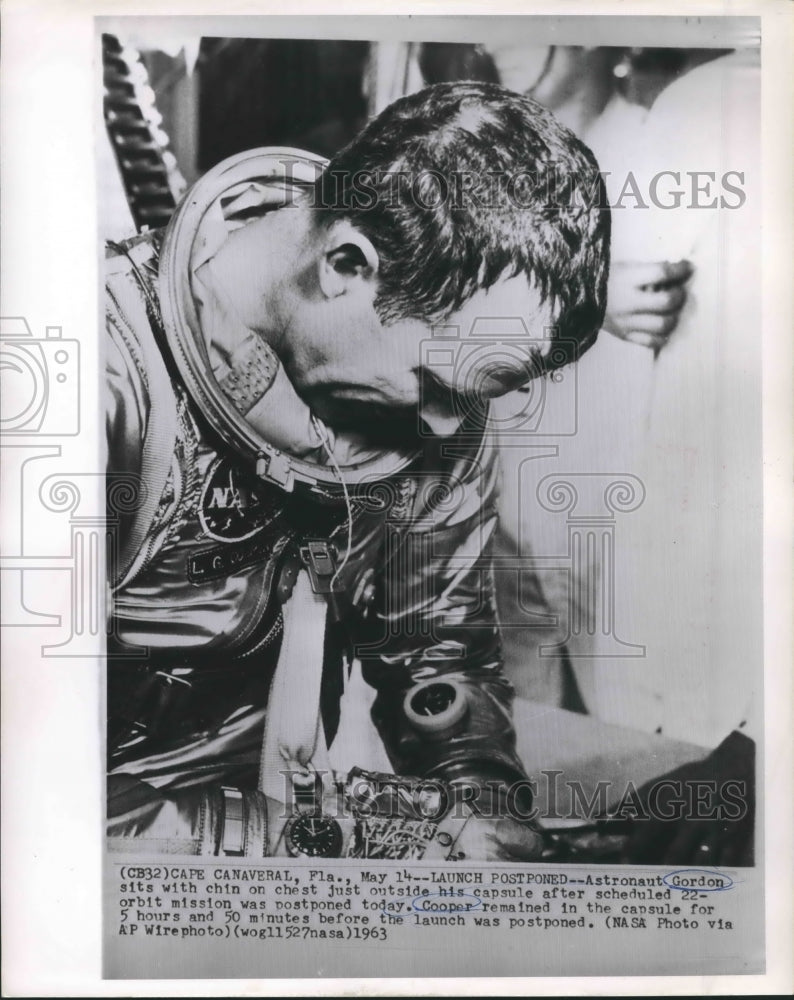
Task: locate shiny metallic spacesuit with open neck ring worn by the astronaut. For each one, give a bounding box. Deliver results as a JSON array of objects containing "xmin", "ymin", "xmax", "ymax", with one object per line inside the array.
[{"xmin": 106, "ymin": 150, "xmax": 536, "ymax": 856}]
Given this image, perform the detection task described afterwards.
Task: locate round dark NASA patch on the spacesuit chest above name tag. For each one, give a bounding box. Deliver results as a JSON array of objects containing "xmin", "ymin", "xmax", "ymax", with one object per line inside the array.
[{"xmin": 199, "ymin": 458, "xmax": 281, "ymax": 542}]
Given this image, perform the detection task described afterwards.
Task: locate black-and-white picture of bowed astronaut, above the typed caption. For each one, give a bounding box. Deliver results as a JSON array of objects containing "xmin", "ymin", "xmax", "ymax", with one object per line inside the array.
[{"xmin": 100, "ymin": 9, "xmax": 761, "ymax": 976}]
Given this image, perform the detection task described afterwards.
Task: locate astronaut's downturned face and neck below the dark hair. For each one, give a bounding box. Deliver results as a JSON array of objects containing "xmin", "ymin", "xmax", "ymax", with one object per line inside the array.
[{"xmin": 281, "ymin": 234, "xmax": 549, "ymax": 435}]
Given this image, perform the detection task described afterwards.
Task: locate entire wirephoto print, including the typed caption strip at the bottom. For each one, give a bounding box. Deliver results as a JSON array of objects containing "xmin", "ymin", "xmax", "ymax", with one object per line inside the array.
[{"xmin": 1, "ymin": 3, "xmax": 790, "ymax": 995}]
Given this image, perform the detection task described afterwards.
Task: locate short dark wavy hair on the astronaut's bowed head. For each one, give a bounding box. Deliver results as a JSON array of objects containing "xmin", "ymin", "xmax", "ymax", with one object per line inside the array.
[{"xmin": 315, "ymin": 81, "xmax": 610, "ymax": 363}]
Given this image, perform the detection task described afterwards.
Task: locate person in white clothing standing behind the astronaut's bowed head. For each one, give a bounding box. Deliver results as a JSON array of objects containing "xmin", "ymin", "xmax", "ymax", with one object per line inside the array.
[{"xmin": 497, "ymin": 45, "xmax": 762, "ymax": 863}]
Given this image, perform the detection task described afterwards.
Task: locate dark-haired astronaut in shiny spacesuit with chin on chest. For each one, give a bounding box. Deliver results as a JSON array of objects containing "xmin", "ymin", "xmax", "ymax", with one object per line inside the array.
[{"xmin": 102, "ymin": 83, "xmax": 609, "ymax": 860}]
